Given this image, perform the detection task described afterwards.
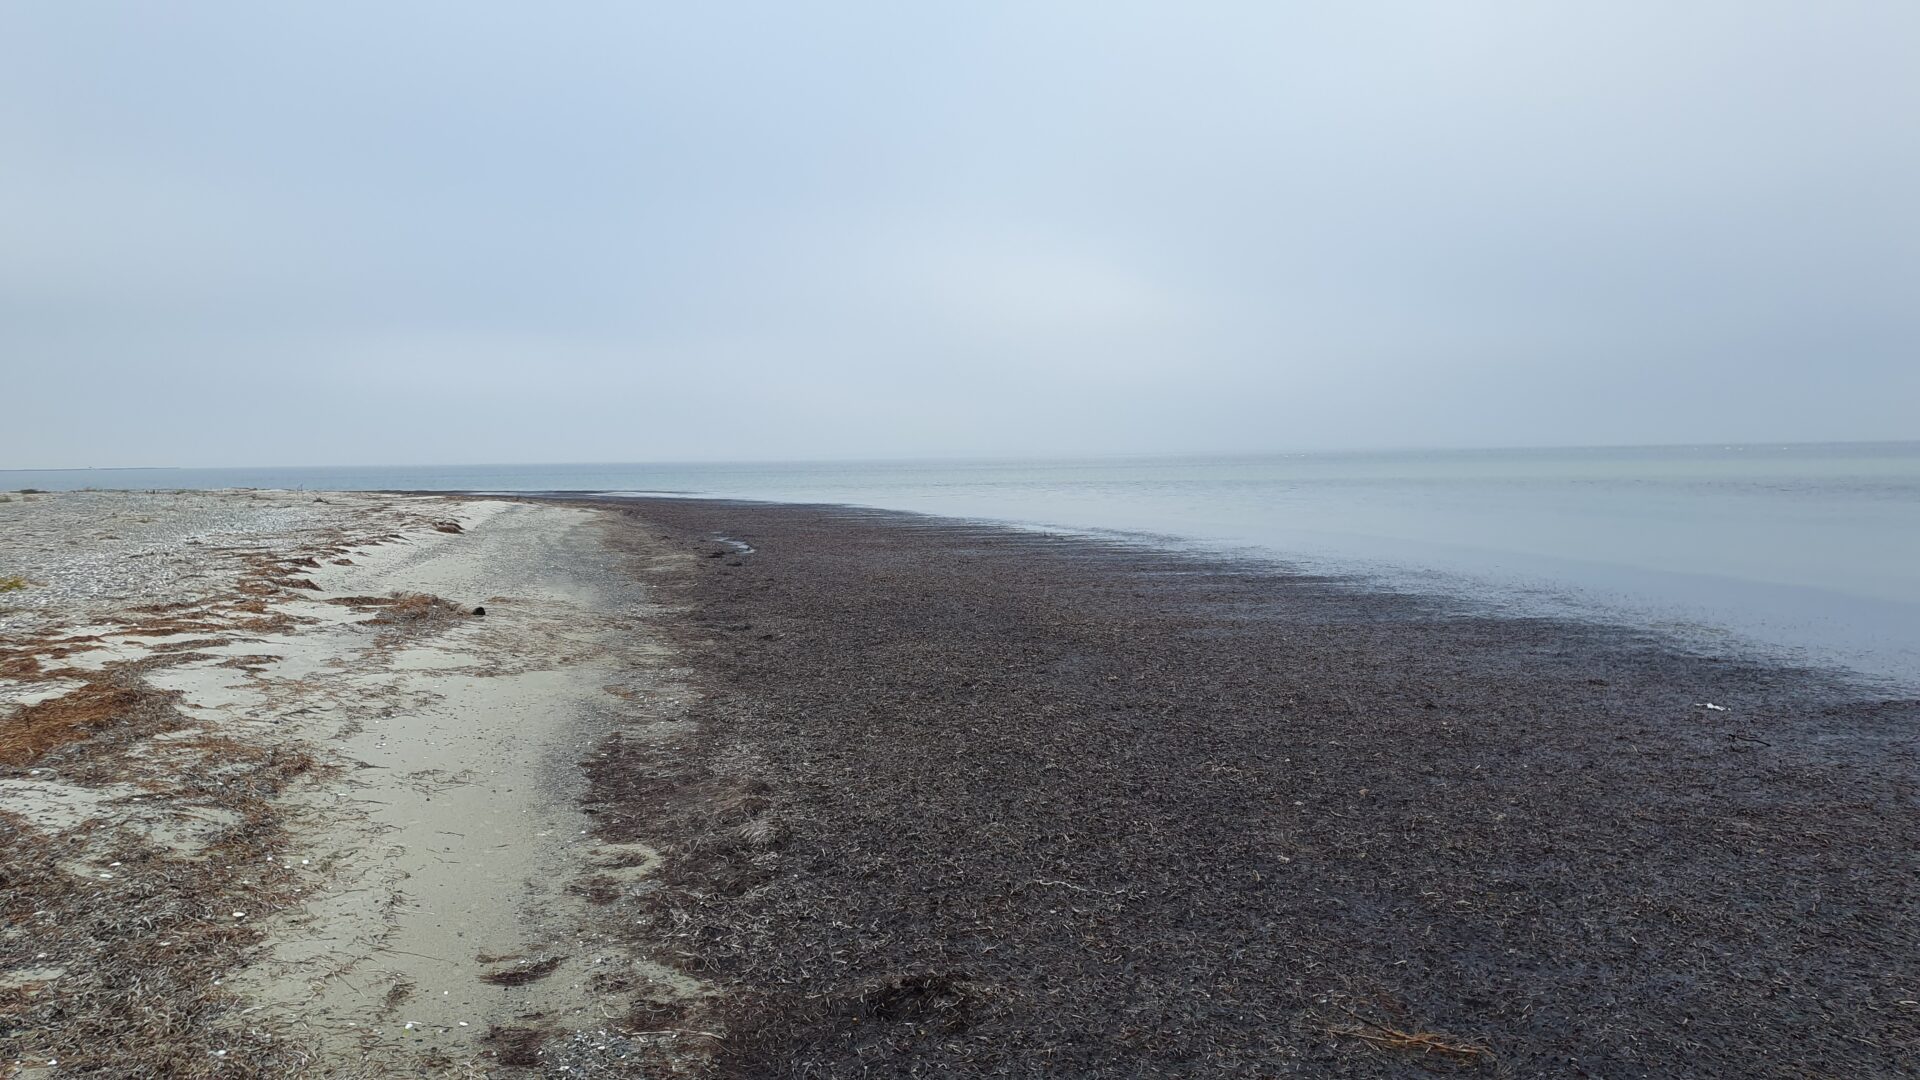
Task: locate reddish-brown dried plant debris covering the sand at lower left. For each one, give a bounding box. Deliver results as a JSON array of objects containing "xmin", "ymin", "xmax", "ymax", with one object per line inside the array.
[{"xmin": 0, "ymin": 653, "xmax": 330, "ymax": 1078}]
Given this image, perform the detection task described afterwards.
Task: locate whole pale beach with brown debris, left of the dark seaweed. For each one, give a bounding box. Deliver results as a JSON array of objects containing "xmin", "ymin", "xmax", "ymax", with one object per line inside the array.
[{"xmin": 0, "ymin": 492, "xmax": 703, "ymax": 1076}]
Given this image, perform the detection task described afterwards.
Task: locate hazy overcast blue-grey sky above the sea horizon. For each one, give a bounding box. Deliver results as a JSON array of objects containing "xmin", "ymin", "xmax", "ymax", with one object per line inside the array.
[{"xmin": 0, "ymin": 0, "xmax": 1920, "ymax": 467}]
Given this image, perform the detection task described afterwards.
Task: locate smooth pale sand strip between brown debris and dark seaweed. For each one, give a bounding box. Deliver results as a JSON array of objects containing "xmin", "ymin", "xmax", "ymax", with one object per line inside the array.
[{"xmin": 219, "ymin": 503, "xmax": 697, "ymax": 1057}]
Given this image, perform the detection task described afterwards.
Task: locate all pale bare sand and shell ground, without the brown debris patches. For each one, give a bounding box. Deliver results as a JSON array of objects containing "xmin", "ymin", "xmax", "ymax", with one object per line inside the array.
[{"xmin": 0, "ymin": 492, "xmax": 701, "ymax": 1076}]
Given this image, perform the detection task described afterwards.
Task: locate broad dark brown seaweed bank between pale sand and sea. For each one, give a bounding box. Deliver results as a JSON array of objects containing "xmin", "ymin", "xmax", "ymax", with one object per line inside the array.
[{"xmin": 589, "ymin": 500, "xmax": 1920, "ymax": 1080}]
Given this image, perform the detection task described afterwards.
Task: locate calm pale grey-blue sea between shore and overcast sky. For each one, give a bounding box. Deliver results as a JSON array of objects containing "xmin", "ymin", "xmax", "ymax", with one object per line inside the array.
[{"xmin": 0, "ymin": 442, "xmax": 1920, "ymax": 688}]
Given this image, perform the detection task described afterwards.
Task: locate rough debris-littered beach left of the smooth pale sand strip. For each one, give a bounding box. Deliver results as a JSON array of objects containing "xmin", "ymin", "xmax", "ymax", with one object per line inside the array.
[{"xmin": 0, "ymin": 492, "xmax": 537, "ymax": 1080}]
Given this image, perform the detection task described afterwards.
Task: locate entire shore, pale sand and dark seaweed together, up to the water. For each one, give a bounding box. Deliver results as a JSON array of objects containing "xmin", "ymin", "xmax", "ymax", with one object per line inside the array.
[{"xmin": 0, "ymin": 492, "xmax": 1920, "ymax": 1078}]
